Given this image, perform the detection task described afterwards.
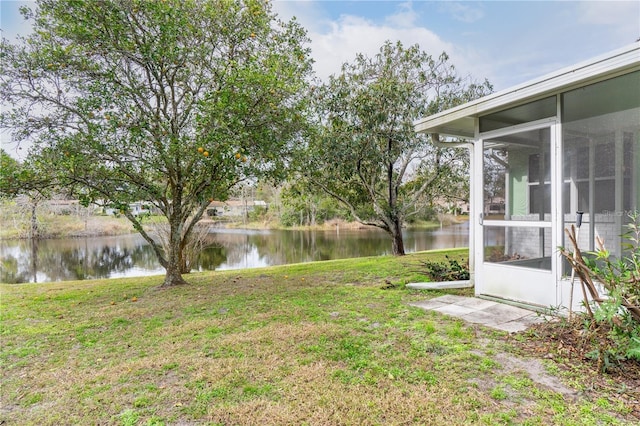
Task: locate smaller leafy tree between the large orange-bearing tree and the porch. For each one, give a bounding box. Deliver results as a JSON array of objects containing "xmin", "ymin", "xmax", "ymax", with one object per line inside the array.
[{"xmin": 300, "ymin": 42, "xmax": 492, "ymax": 255}]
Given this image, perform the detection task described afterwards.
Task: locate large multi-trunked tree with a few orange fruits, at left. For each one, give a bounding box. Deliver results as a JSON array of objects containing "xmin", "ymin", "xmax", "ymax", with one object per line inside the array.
[{"xmin": 0, "ymin": 0, "xmax": 311, "ymax": 286}]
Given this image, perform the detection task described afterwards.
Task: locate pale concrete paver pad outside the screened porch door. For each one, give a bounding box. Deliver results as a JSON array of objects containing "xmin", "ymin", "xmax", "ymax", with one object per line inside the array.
[{"xmin": 409, "ymin": 295, "xmax": 545, "ymax": 333}]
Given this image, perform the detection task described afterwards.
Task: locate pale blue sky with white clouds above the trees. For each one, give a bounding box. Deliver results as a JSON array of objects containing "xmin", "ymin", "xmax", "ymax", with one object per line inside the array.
[{"xmin": 0, "ymin": 0, "xmax": 640, "ymax": 156}]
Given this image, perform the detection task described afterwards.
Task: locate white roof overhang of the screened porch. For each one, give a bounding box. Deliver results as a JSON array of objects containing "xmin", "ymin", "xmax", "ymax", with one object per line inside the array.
[{"xmin": 414, "ymin": 42, "xmax": 640, "ymax": 139}]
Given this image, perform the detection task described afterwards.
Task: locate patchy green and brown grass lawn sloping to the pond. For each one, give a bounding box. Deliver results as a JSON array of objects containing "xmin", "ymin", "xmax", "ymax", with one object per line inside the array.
[{"xmin": 0, "ymin": 251, "xmax": 638, "ymax": 425}]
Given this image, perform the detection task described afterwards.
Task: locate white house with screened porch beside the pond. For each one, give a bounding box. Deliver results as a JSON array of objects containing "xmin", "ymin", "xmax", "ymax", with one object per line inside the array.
[{"xmin": 415, "ymin": 42, "xmax": 640, "ymax": 309}]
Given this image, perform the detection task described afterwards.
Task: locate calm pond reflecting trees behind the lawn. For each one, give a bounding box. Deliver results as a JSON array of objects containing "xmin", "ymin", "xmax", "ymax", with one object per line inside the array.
[{"xmin": 0, "ymin": 223, "xmax": 476, "ymax": 283}]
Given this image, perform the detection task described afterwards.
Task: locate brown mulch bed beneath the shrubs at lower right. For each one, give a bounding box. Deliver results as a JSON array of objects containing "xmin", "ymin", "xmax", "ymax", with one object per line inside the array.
[{"xmin": 507, "ymin": 318, "xmax": 640, "ymax": 419}]
